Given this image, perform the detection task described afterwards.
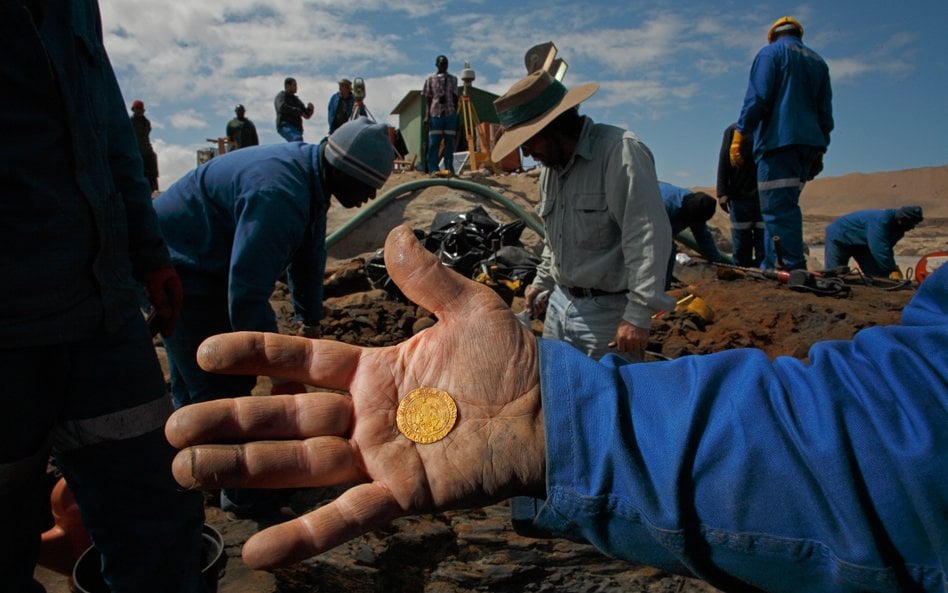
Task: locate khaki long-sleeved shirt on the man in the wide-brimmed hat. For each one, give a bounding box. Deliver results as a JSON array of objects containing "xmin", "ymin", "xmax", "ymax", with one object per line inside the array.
[{"xmin": 533, "ymin": 117, "xmax": 675, "ymax": 328}]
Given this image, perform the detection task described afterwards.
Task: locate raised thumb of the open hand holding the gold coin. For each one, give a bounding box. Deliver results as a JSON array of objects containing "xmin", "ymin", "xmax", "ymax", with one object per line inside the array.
[{"xmin": 385, "ymin": 225, "xmax": 506, "ymax": 319}]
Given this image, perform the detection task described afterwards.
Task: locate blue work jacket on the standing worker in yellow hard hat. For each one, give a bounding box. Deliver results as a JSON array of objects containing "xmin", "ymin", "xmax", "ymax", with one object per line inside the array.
[{"xmin": 737, "ymin": 35, "xmax": 833, "ymax": 160}]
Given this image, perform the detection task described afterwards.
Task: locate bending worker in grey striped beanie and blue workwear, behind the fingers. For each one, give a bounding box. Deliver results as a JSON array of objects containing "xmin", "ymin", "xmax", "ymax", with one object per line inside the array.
[{"xmin": 154, "ymin": 118, "xmax": 394, "ymax": 517}]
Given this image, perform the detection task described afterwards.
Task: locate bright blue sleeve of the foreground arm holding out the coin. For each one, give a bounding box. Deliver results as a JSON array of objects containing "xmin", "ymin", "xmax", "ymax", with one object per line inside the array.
[{"xmin": 536, "ymin": 269, "xmax": 948, "ymax": 592}]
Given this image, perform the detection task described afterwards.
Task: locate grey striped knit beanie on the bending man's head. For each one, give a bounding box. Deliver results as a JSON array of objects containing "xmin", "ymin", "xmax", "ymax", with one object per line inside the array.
[{"xmin": 326, "ymin": 117, "xmax": 395, "ymax": 189}]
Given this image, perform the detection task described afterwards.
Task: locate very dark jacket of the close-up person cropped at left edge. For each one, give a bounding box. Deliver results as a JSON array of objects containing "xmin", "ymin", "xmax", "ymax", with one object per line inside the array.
[{"xmin": 0, "ymin": 0, "xmax": 170, "ymax": 347}]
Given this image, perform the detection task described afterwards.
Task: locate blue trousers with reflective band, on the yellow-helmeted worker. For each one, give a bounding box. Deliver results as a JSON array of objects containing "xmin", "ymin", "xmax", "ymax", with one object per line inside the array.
[{"xmin": 757, "ymin": 145, "xmax": 821, "ymax": 270}]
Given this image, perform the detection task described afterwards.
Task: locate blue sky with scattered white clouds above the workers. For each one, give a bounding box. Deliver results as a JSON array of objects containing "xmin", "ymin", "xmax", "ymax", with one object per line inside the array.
[{"xmin": 101, "ymin": 0, "xmax": 948, "ymax": 189}]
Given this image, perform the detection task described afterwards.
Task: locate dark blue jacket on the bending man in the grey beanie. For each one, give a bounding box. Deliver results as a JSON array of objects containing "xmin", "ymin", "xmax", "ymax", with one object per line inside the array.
[{"xmin": 155, "ymin": 142, "xmax": 329, "ymax": 332}]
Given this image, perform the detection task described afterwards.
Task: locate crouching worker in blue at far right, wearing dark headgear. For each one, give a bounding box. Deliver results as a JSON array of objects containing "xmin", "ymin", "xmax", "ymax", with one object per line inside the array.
[{"xmin": 825, "ymin": 206, "xmax": 924, "ymax": 280}]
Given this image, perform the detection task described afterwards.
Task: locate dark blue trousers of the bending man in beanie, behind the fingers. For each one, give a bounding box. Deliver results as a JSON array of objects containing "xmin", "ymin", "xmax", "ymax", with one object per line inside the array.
[{"xmin": 164, "ymin": 292, "xmax": 276, "ymax": 515}]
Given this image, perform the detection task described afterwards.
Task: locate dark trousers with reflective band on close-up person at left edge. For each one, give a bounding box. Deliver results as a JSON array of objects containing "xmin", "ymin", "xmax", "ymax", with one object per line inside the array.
[{"xmin": 0, "ymin": 310, "xmax": 204, "ymax": 593}]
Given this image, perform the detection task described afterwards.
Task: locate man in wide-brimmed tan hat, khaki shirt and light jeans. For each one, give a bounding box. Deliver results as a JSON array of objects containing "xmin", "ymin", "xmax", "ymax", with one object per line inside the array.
[{"xmin": 491, "ymin": 70, "xmax": 675, "ymax": 360}]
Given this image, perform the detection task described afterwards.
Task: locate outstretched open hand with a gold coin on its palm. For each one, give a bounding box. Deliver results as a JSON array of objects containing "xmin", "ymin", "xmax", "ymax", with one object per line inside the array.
[{"xmin": 166, "ymin": 227, "xmax": 545, "ymax": 568}]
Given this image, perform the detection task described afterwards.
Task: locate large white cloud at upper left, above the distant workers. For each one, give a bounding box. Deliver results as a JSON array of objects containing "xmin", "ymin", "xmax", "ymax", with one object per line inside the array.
[{"xmin": 103, "ymin": 0, "xmax": 407, "ymax": 100}]
